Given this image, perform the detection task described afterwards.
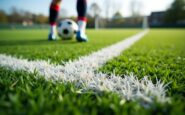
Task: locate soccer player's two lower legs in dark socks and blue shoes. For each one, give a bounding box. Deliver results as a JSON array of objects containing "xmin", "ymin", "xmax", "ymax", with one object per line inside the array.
[{"xmin": 48, "ymin": 0, "xmax": 88, "ymax": 42}]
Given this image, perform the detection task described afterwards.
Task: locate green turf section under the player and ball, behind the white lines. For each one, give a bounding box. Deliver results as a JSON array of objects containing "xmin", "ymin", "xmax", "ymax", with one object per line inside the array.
[{"xmin": 0, "ymin": 29, "xmax": 141, "ymax": 64}]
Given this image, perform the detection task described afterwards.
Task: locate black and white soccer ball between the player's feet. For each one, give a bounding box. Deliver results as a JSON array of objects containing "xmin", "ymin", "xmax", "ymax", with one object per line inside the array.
[{"xmin": 58, "ymin": 19, "xmax": 78, "ymax": 40}]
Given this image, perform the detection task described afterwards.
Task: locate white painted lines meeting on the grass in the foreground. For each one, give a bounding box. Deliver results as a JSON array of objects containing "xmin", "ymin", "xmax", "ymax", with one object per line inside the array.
[{"xmin": 0, "ymin": 30, "xmax": 168, "ymax": 102}]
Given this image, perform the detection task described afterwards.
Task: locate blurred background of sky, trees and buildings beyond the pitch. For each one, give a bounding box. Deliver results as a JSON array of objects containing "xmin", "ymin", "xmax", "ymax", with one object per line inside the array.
[{"xmin": 0, "ymin": 0, "xmax": 185, "ymax": 29}]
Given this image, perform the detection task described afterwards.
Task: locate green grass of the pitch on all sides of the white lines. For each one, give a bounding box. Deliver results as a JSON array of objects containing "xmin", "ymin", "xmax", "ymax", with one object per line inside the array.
[{"xmin": 0, "ymin": 29, "xmax": 185, "ymax": 115}]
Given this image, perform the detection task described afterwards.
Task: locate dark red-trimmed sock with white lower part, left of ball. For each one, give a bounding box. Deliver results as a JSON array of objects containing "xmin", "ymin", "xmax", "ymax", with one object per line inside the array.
[{"xmin": 49, "ymin": 3, "xmax": 60, "ymax": 35}]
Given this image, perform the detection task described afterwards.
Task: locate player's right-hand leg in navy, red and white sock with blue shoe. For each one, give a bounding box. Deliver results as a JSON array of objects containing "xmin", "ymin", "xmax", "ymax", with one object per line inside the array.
[{"xmin": 76, "ymin": 0, "xmax": 88, "ymax": 42}]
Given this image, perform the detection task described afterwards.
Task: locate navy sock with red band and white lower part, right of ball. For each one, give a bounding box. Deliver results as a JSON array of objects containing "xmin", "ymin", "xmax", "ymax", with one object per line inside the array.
[{"xmin": 77, "ymin": 0, "xmax": 87, "ymax": 33}]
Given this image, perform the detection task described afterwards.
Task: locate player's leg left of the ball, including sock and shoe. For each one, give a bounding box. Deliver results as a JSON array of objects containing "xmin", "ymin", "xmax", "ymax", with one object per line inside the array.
[{"xmin": 48, "ymin": 0, "xmax": 62, "ymax": 40}]
